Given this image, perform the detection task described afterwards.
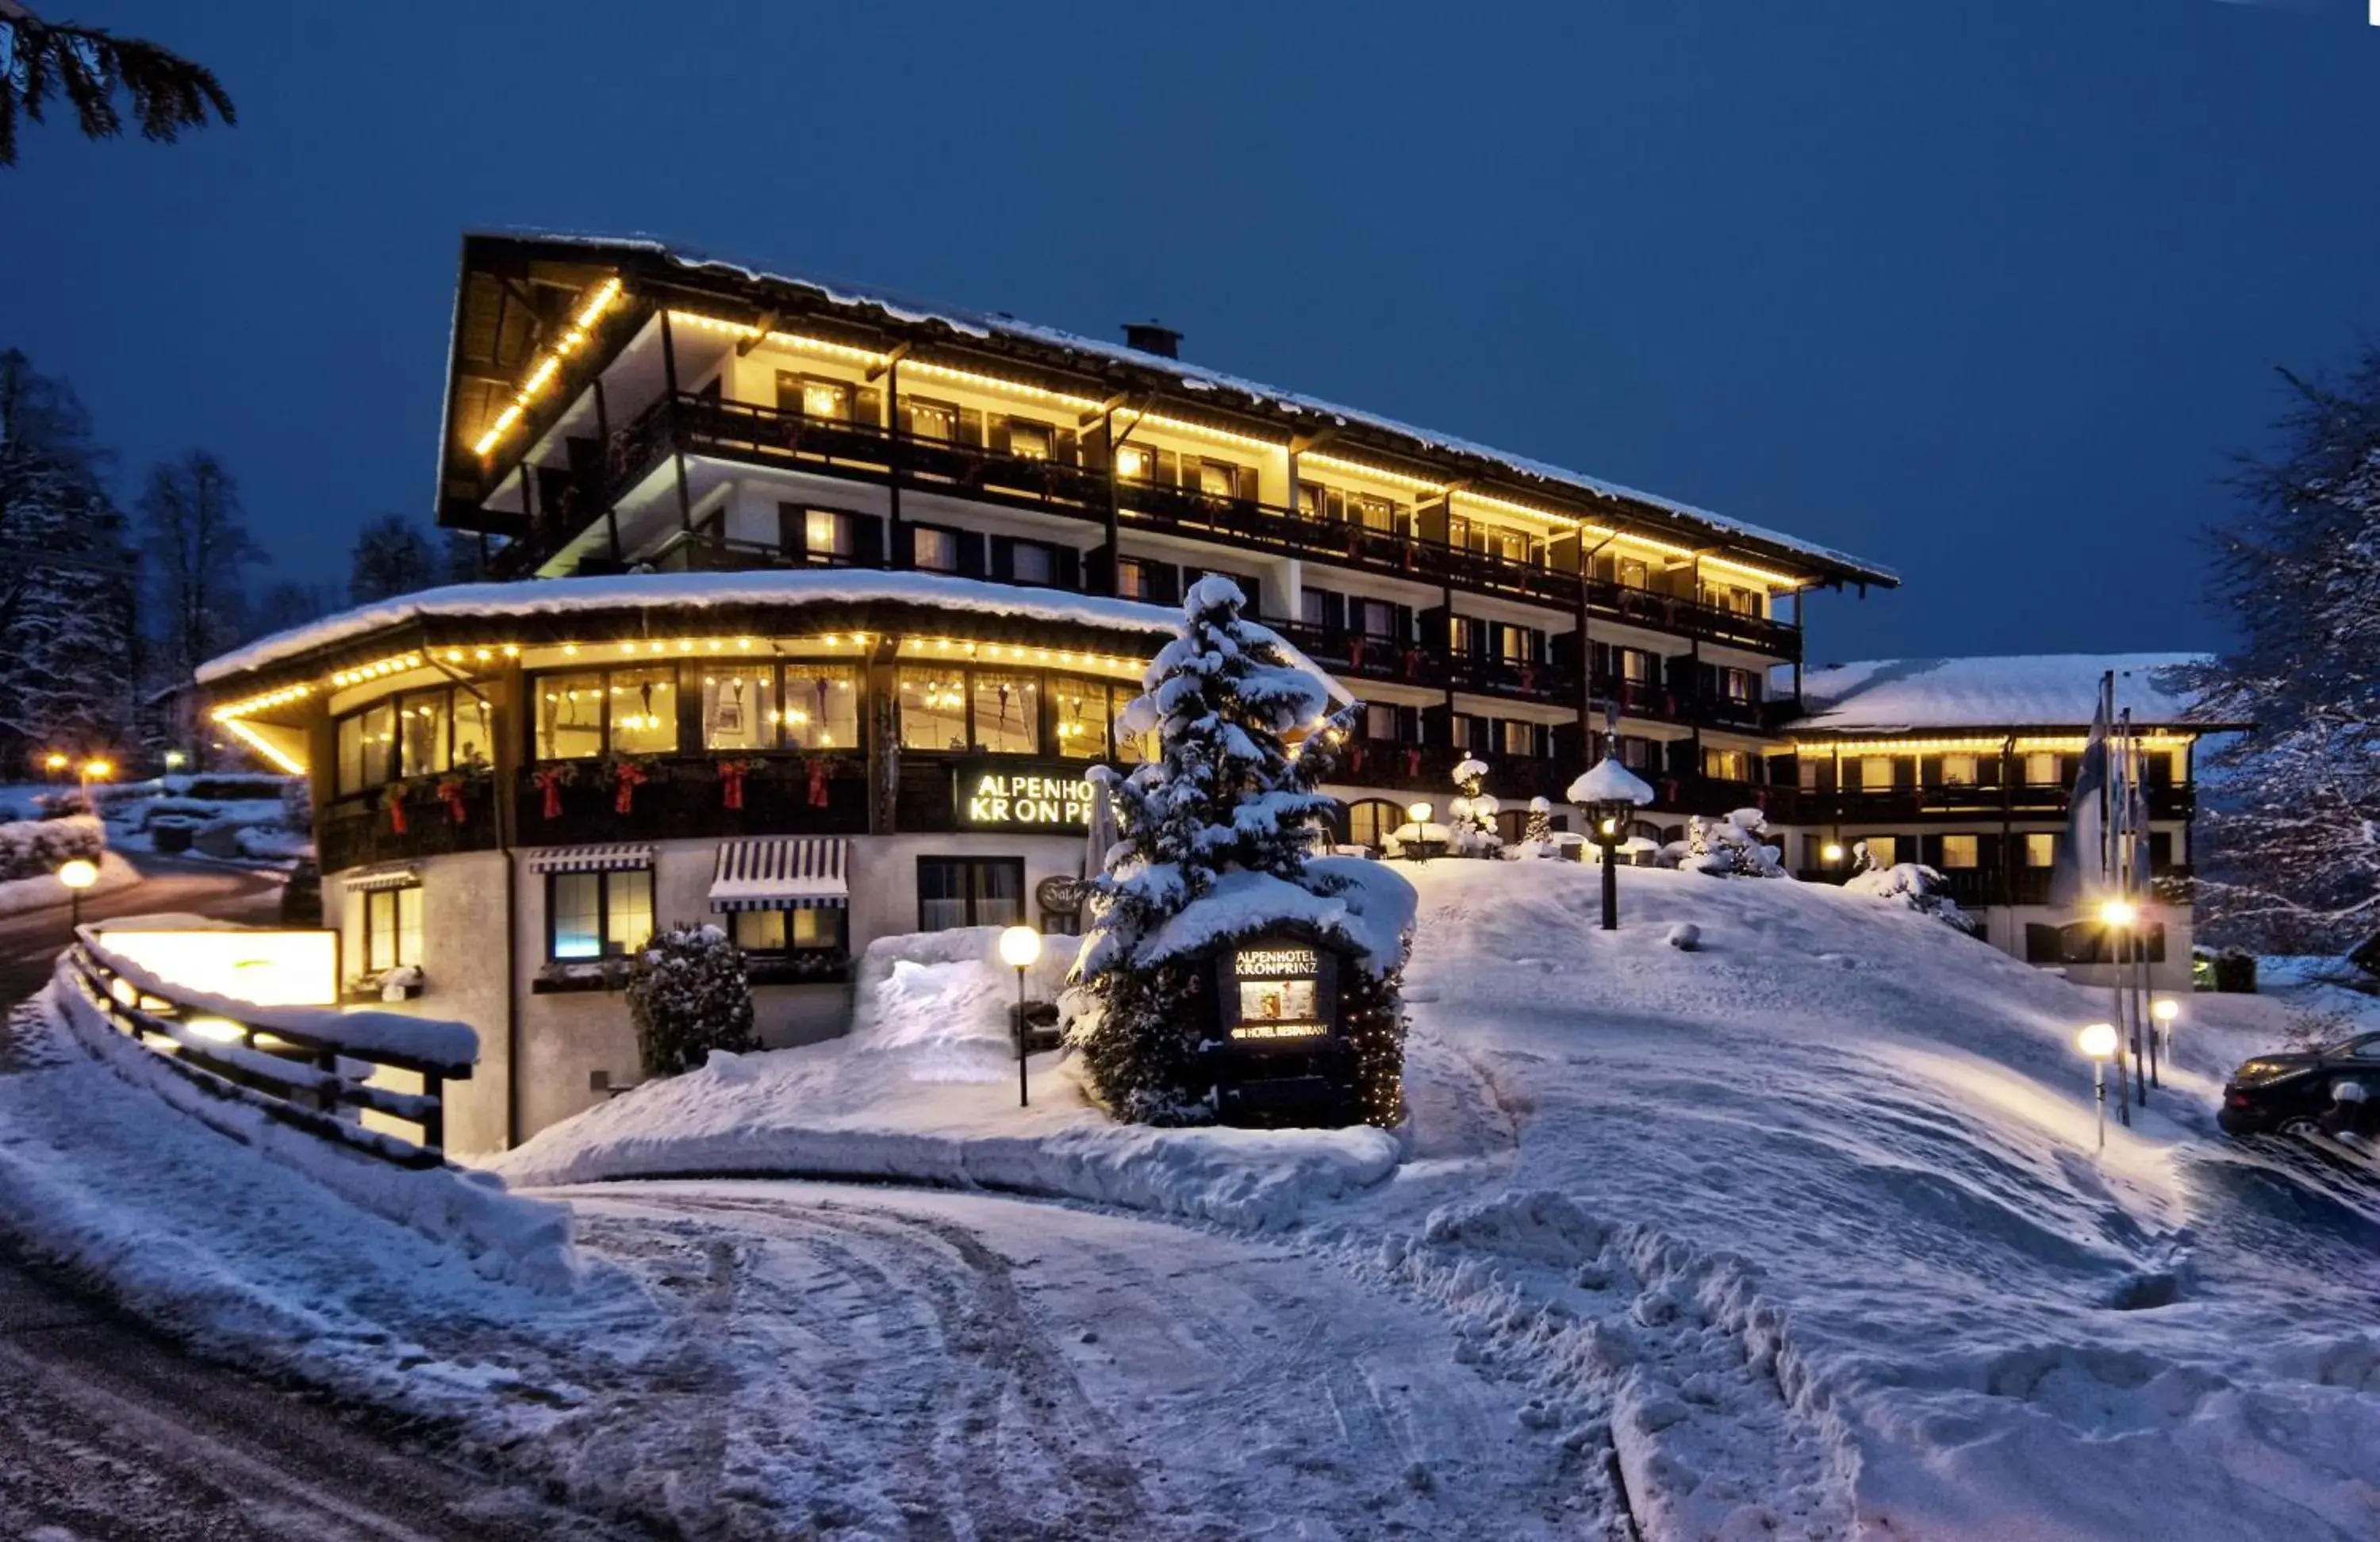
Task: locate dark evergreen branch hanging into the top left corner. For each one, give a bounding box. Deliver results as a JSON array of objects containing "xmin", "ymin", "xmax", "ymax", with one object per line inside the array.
[{"xmin": 0, "ymin": 0, "xmax": 238, "ymax": 167}]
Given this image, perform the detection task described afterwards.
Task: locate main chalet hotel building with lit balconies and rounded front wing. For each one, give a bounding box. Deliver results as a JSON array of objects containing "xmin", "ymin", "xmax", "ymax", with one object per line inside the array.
[{"xmin": 202, "ymin": 236, "xmax": 1897, "ymax": 1149}]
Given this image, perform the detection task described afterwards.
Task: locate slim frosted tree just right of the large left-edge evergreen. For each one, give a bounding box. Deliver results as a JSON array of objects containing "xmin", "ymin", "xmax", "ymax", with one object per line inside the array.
[{"xmin": 140, "ymin": 450, "xmax": 264, "ymax": 688}]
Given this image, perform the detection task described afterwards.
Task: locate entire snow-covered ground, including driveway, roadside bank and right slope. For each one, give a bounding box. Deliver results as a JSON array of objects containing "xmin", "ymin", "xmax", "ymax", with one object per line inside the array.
[{"xmin": 0, "ymin": 861, "xmax": 2380, "ymax": 1542}]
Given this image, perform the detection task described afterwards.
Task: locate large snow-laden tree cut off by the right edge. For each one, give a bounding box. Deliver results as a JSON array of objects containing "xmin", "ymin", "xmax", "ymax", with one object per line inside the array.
[{"xmin": 2178, "ymin": 350, "xmax": 2380, "ymax": 952}]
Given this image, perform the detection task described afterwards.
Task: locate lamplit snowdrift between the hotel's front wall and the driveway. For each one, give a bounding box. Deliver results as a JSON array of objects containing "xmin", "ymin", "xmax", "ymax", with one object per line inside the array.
[{"xmin": 488, "ymin": 928, "xmax": 1399, "ymax": 1228}]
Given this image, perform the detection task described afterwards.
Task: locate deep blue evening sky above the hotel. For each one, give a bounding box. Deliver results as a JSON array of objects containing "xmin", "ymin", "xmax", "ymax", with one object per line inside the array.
[{"xmin": 0, "ymin": 0, "xmax": 2380, "ymax": 662}]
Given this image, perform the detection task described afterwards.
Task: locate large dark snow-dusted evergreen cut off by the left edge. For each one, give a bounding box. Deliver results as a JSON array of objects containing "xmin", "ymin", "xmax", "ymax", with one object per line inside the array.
[{"xmin": 0, "ymin": 350, "xmax": 136, "ymax": 769}]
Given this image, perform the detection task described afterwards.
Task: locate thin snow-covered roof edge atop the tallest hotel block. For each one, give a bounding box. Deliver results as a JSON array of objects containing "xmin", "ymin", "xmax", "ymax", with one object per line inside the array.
[{"xmin": 486, "ymin": 228, "xmax": 1899, "ymax": 585}]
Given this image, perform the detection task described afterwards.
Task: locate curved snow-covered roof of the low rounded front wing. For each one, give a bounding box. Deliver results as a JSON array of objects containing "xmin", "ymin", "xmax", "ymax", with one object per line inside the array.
[{"xmin": 198, "ymin": 569, "xmax": 1354, "ymax": 702}]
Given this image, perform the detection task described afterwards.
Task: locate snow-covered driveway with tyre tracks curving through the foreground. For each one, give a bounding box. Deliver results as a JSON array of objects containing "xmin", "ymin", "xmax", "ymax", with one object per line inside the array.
[{"xmin": 552, "ymin": 1183, "xmax": 1606, "ymax": 1540}]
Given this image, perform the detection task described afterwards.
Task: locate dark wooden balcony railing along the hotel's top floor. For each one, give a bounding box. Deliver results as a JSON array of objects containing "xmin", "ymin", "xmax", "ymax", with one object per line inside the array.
[{"xmin": 497, "ymin": 393, "xmax": 1802, "ymax": 659}]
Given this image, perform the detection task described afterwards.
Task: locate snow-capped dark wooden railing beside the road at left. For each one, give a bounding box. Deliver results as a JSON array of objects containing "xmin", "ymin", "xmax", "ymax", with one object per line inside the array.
[{"xmin": 62, "ymin": 926, "xmax": 478, "ymax": 1168}]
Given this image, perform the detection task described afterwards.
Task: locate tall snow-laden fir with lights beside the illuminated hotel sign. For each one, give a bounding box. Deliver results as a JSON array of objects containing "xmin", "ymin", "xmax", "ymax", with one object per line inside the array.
[{"xmin": 1064, "ymin": 576, "xmax": 1402, "ymax": 1123}]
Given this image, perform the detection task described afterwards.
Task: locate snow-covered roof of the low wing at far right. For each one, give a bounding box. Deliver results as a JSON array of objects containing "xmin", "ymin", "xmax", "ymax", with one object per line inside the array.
[{"xmin": 1785, "ymin": 654, "xmax": 2209, "ymax": 738}]
